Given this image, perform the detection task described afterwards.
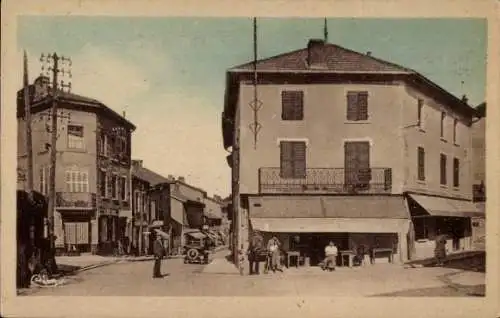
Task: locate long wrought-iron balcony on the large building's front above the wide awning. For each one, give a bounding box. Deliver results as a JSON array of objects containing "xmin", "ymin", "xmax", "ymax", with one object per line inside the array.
[{"xmin": 259, "ymin": 167, "xmax": 392, "ymax": 194}]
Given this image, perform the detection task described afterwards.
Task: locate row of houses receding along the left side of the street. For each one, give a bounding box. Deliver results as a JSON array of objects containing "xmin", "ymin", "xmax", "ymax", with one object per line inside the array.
[{"xmin": 17, "ymin": 77, "xmax": 227, "ymax": 254}]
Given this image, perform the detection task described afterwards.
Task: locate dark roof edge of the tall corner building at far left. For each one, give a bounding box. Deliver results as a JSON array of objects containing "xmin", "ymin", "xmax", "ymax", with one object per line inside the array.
[{"xmin": 17, "ymin": 85, "xmax": 136, "ymax": 130}]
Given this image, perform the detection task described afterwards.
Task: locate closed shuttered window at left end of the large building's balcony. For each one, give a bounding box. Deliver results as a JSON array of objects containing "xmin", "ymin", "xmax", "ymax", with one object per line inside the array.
[{"xmin": 280, "ymin": 141, "xmax": 306, "ymax": 178}]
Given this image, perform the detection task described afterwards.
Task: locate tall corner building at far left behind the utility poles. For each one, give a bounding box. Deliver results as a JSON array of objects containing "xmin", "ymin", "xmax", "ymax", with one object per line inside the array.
[{"xmin": 17, "ymin": 77, "xmax": 135, "ymax": 253}]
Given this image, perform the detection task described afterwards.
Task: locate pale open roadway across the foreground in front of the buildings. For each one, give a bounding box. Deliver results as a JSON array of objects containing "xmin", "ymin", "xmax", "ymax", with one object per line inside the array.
[{"xmin": 22, "ymin": 252, "xmax": 484, "ymax": 297}]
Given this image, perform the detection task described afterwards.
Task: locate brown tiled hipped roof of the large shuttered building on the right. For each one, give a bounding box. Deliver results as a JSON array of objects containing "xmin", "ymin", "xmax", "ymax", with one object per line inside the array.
[{"xmin": 230, "ymin": 43, "xmax": 414, "ymax": 73}]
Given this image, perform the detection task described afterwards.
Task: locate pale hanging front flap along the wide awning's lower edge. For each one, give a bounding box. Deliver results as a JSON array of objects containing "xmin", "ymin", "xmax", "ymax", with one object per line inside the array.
[{"xmin": 251, "ymin": 218, "xmax": 409, "ymax": 233}]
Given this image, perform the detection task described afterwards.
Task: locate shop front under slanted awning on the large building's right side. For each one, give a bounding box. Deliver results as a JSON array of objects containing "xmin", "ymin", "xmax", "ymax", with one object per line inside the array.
[{"xmin": 407, "ymin": 194, "xmax": 484, "ymax": 259}]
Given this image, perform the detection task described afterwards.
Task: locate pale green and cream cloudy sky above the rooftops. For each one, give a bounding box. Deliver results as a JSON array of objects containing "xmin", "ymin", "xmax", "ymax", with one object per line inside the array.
[{"xmin": 17, "ymin": 16, "xmax": 487, "ymax": 196}]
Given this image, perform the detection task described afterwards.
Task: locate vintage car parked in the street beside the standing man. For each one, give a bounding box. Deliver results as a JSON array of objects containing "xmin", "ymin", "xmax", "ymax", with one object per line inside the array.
[{"xmin": 184, "ymin": 230, "xmax": 213, "ymax": 264}]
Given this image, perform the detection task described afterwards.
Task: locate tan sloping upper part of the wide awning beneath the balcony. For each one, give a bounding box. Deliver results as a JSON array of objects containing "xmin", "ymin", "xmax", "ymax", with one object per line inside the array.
[{"xmin": 249, "ymin": 196, "xmax": 409, "ymax": 219}]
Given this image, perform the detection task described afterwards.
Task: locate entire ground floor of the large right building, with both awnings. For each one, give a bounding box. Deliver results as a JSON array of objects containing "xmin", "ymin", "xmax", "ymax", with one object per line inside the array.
[{"xmin": 234, "ymin": 194, "xmax": 484, "ymax": 265}]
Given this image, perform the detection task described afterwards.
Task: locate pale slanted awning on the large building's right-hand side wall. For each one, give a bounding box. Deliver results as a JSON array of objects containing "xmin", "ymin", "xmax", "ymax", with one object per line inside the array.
[{"xmin": 410, "ymin": 194, "xmax": 484, "ymax": 217}]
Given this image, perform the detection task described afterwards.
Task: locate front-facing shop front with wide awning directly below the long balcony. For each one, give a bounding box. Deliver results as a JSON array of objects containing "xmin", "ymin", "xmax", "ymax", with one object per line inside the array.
[{"xmin": 249, "ymin": 196, "xmax": 410, "ymax": 266}]
